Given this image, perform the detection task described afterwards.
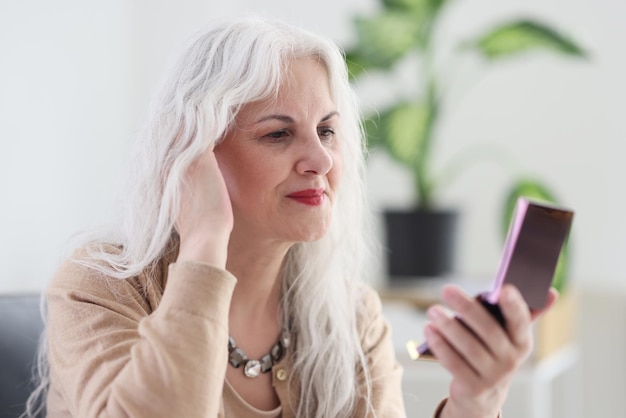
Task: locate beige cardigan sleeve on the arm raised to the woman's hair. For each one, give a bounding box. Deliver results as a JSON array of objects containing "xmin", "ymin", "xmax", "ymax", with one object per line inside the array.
[{"xmin": 48, "ymin": 262, "xmax": 236, "ymax": 418}]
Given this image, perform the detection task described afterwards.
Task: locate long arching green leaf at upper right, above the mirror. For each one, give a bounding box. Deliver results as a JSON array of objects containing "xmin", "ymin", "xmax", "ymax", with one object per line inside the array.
[{"xmin": 470, "ymin": 20, "xmax": 587, "ymax": 60}]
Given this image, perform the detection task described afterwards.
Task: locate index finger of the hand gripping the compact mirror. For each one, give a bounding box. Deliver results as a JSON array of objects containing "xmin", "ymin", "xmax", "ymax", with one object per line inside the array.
[{"xmin": 498, "ymin": 284, "xmax": 532, "ymax": 352}]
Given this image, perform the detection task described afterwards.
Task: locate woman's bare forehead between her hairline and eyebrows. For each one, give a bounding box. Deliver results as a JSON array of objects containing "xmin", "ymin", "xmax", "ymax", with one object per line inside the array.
[{"xmin": 237, "ymin": 57, "xmax": 336, "ymax": 123}]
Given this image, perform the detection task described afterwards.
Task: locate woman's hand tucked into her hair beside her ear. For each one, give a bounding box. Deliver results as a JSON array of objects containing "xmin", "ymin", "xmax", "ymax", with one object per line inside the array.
[{"xmin": 176, "ymin": 148, "xmax": 233, "ymax": 268}]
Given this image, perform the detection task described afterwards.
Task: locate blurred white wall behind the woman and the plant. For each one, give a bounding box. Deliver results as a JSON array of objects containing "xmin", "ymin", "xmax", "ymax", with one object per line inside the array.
[{"xmin": 0, "ymin": 0, "xmax": 626, "ymax": 417}]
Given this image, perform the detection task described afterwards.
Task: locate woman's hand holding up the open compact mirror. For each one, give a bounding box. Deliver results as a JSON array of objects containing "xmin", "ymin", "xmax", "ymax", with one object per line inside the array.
[{"xmin": 425, "ymin": 285, "xmax": 558, "ymax": 418}]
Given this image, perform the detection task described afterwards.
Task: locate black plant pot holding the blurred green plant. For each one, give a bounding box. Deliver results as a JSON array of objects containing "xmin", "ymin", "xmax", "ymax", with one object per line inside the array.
[{"xmin": 384, "ymin": 210, "xmax": 458, "ymax": 281}]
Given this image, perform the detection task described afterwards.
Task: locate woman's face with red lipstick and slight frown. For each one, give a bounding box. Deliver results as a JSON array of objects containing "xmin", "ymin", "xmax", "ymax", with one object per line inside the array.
[{"xmin": 215, "ymin": 58, "xmax": 342, "ymax": 243}]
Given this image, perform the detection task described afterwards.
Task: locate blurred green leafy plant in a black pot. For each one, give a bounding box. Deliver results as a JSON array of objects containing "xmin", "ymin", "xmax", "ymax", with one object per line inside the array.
[{"xmin": 346, "ymin": 0, "xmax": 586, "ymax": 288}]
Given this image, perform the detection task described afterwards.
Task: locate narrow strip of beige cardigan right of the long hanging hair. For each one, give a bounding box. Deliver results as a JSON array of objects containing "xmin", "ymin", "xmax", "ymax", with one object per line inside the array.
[{"xmin": 355, "ymin": 288, "xmax": 406, "ymax": 418}]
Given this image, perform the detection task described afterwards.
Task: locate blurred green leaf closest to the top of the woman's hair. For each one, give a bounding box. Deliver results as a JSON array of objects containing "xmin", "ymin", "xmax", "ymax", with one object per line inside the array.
[{"xmin": 352, "ymin": 11, "xmax": 420, "ymax": 69}]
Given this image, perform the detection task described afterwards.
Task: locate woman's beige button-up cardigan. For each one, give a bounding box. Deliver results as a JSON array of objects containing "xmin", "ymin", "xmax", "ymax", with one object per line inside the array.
[{"xmin": 47, "ymin": 250, "xmax": 428, "ymax": 418}]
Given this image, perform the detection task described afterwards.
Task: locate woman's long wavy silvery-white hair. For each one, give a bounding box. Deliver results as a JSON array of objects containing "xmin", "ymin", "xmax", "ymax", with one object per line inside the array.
[{"xmin": 24, "ymin": 18, "xmax": 374, "ymax": 418}]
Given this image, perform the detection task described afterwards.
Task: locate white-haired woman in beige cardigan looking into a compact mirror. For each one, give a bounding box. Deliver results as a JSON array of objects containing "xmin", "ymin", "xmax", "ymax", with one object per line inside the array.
[{"xmin": 29, "ymin": 19, "xmax": 553, "ymax": 418}]
